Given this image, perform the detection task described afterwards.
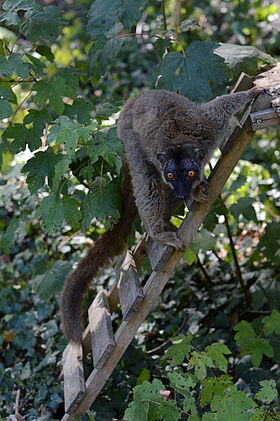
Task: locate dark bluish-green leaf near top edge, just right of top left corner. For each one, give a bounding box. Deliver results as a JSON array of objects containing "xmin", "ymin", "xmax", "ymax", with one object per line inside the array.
[{"xmin": 20, "ymin": 6, "xmax": 64, "ymax": 42}]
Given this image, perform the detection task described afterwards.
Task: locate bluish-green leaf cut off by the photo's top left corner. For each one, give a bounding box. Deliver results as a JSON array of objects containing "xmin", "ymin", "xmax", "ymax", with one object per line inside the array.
[{"xmin": 0, "ymin": 0, "xmax": 40, "ymax": 25}]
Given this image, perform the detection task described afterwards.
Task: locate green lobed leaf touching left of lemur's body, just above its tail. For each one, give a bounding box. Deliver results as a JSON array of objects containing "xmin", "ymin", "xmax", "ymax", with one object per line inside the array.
[{"xmin": 81, "ymin": 179, "xmax": 120, "ymax": 233}]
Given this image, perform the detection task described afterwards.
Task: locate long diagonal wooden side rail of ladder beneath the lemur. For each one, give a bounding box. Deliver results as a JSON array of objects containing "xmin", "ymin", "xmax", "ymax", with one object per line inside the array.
[{"xmin": 63, "ymin": 102, "xmax": 258, "ymax": 415}]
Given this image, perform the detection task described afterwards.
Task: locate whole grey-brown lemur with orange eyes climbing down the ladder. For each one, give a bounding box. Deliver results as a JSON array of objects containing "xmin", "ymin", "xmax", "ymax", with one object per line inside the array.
[{"xmin": 61, "ymin": 87, "xmax": 260, "ymax": 343}]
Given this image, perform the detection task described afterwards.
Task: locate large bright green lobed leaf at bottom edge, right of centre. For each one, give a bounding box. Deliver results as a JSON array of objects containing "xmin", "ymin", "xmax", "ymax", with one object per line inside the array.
[{"xmin": 211, "ymin": 386, "xmax": 257, "ymax": 421}]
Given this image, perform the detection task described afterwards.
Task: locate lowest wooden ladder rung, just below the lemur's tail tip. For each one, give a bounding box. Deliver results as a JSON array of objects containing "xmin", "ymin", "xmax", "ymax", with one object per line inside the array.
[{"xmin": 63, "ymin": 344, "xmax": 85, "ymax": 413}]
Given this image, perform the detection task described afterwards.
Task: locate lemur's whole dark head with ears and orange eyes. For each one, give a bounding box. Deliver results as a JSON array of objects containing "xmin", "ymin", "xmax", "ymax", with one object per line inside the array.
[{"xmin": 157, "ymin": 145, "xmax": 205, "ymax": 200}]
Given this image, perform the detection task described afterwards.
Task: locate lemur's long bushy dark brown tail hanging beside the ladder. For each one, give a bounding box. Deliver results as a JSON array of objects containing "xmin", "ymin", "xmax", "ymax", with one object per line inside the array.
[{"xmin": 61, "ymin": 162, "xmax": 137, "ymax": 343}]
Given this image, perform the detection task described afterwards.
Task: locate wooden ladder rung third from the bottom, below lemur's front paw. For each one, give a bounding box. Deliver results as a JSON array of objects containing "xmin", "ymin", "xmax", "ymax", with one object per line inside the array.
[{"xmin": 118, "ymin": 251, "xmax": 144, "ymax": 320}]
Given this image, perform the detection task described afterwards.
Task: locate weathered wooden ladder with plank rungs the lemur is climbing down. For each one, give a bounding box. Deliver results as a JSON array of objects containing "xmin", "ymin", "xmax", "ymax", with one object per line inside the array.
[{"xmin": 62, "ymin": 66, "xmax": 280, "ymax": 421}]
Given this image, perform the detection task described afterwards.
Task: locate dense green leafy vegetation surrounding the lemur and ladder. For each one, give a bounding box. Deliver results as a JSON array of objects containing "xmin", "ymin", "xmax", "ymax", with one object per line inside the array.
[{"xmin": 0, "ymin": 0, "xmax": 280, "ymax": 421}]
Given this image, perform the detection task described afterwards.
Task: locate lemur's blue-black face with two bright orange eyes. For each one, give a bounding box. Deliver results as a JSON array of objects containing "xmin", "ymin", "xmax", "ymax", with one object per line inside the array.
[{"xmin": 163, "ymin": 159, "xmax": 200, "ymax": 200}]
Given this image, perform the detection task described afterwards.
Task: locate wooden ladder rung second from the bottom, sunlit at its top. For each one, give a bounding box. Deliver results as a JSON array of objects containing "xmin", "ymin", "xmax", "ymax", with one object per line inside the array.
[{"xmin": 88, "ymin": 290, "xmax": 115, "ymax": 368}]
